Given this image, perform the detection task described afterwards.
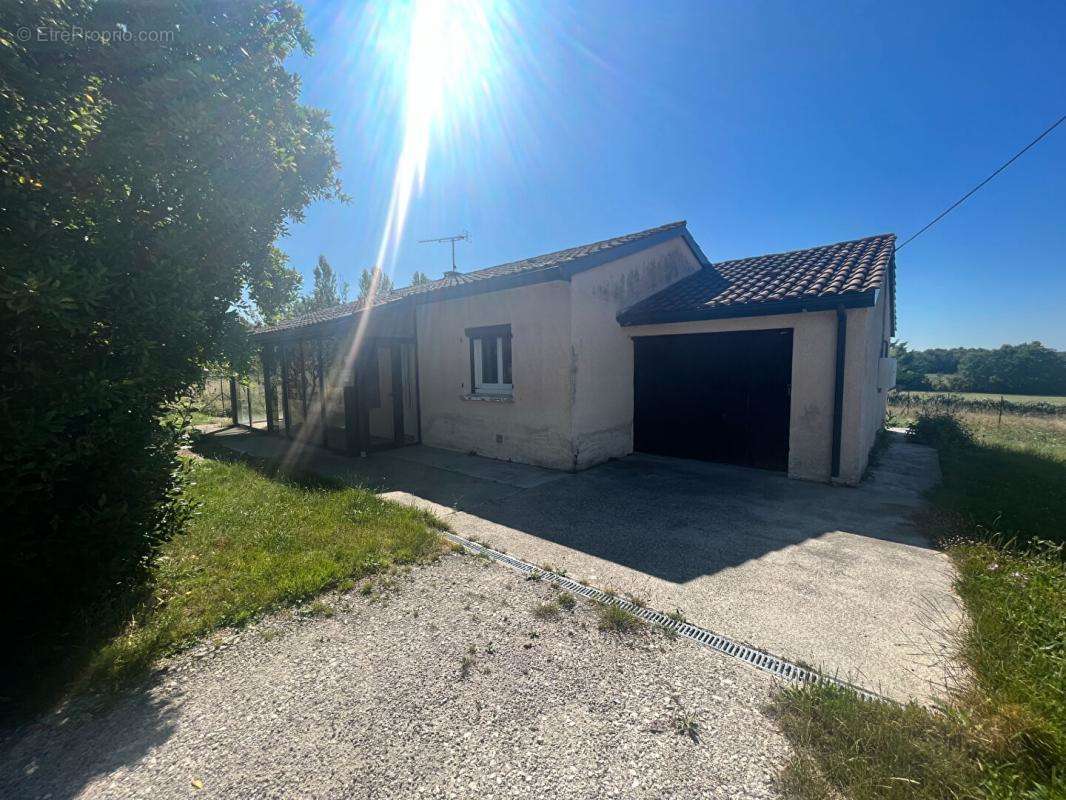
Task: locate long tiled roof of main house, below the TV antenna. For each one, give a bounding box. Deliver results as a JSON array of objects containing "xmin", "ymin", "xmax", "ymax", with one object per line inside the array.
[{"xmin": 261, "ymin": 220, "xmax": 685, "ymax": 334}]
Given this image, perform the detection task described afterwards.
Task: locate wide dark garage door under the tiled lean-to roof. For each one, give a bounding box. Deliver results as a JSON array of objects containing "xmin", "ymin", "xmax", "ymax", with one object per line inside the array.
[{"xmin": 633, "ymin": 329, "xmax": 792, "ymax": 469}]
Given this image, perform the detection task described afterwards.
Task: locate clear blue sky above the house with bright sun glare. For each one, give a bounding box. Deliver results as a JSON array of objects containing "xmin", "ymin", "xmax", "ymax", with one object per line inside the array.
[{"xmin": 280, "ymin": 0, "xmax": 1066, "ymax": 349}]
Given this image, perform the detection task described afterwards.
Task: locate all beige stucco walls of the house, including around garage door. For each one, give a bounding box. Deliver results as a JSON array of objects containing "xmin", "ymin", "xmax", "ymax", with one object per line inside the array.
[{"xmin": 417, "ymin": 231, "xmax": 890, "ymax": 483}]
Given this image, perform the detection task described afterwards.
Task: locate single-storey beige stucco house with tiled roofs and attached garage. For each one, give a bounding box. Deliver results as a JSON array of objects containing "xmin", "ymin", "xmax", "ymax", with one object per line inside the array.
[{"xmin": 256, "ymin": 222, "xmax": 895, "ymax": 483}]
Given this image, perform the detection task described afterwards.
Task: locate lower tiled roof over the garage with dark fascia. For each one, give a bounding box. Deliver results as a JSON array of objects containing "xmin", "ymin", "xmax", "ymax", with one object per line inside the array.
[{"xmin": 618, "ymin": 234, "xmax": 895, "ymax": 325}]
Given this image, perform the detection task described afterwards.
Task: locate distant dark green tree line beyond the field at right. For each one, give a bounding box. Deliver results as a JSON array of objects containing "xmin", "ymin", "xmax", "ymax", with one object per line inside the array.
[{"xmin": 892, "ymin": 341, "xmax": 1066, "ymax": 395}]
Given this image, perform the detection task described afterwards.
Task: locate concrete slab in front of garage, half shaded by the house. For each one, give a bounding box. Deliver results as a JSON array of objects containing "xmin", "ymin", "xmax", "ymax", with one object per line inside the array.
[{"xmin": 203, "ymin": 426, "xmax": 963, "ymax": 700}]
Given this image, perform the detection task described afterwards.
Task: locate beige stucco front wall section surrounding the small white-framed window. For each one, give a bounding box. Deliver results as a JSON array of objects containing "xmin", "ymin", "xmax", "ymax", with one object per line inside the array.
[{"xmin": 417, "ymin": 281, "xmax": 571, "ymax": 469}]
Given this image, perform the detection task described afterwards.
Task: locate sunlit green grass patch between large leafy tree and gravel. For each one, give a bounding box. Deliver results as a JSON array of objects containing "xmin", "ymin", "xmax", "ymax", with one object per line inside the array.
[{"xmin": 83, "ymin": 448, "xmax": 442, "ymax": 687}]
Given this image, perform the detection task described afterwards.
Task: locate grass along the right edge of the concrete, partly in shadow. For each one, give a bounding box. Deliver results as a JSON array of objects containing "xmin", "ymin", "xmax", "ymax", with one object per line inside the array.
[{"xmin": 775, "ymin": 414, "xmax": 1066, "ymax": 800}]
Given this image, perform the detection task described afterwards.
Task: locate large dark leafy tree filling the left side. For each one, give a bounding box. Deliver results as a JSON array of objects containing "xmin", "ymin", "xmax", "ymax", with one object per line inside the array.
[{"xmin": 0, "ymin": 0, "xmax": 340, "ymax": 695}]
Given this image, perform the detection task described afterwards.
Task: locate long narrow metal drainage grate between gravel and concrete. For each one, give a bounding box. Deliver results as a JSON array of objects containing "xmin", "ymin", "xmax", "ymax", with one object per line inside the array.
[{"xmin": 445, "ymin": 531, "xmax": 891, "ymax": 702}]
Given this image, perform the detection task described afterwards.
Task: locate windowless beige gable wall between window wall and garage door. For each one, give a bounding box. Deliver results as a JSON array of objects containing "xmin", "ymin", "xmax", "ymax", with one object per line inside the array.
[{"xmin": 568, "ymin": 238, "xmax": 699, "ymax": 469}]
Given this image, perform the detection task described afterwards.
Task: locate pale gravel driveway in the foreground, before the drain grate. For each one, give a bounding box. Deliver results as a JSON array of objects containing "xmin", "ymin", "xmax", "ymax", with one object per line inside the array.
[{"xmin": 0, "ymin": 555, "xmax": 790, "ymax": 800}]
